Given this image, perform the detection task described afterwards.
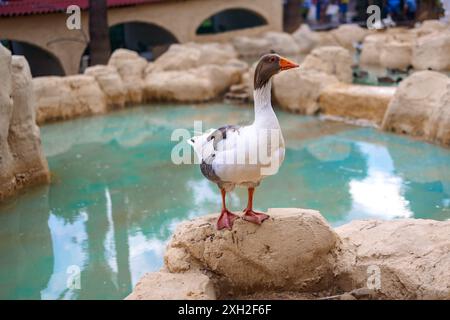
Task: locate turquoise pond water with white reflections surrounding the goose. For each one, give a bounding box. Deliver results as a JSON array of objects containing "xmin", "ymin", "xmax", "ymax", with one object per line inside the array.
[{"xmin": 0, "ymin": 104, "xmax": 450, "ymax": 299}]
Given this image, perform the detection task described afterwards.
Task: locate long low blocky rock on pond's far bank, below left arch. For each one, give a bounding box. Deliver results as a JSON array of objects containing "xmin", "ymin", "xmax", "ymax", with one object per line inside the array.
[{"xmin": 33, "ymin": 75, "xmax": 107, "ymax": 123}]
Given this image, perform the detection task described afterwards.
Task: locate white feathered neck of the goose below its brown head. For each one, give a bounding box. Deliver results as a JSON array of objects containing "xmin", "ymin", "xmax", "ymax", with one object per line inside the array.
[{"xmin": 253, "ymin": 80, "xmax": 280, "ymax": 129}]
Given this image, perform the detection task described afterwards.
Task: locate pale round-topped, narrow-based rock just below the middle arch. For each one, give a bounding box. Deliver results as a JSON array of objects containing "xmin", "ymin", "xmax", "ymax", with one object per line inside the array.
[{"xmin": 108, "ymin": 49, "xmax": 148, "ymax": 104}]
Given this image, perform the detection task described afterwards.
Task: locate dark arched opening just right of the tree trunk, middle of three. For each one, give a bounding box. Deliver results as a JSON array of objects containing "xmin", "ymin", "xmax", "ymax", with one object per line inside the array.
[{"xmin": 110, "ymin": 20, "xmax": 179, "ymax": 60}]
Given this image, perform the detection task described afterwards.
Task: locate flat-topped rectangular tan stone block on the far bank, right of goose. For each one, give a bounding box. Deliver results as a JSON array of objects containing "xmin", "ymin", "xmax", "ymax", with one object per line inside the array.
[{"xmin": 319, "ymin": 83, "xmax": 396, "ymax": 124}]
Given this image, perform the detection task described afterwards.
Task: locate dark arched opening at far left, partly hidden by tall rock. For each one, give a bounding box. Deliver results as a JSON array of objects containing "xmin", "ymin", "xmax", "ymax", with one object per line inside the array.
[{"xmin": 1, "ymin": 39, "xmax": 65, "ymax": 77}]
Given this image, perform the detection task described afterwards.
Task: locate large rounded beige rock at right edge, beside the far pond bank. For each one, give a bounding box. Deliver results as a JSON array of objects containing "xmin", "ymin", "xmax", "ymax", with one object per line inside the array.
[{"xmin": 382, "ymin": 71, "xmax": 450, "ymax": 146}]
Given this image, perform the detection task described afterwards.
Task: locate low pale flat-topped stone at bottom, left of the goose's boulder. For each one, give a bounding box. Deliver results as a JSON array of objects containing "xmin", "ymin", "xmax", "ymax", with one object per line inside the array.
[{"xmin": 126, "ymin": 272, "xmax": 216, "ymax": 300}]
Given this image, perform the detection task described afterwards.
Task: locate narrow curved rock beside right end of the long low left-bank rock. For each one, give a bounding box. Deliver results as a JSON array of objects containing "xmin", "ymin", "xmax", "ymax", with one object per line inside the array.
[{"xmin": 84, "ymin": 65, "xmax": 127, "ymax": 109}]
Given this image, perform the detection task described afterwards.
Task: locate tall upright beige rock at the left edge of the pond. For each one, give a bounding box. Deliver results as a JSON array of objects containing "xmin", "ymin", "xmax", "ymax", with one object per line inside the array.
[{"xmin": 0, "ymin": 44, "xmax": 50, "ymax": 201}]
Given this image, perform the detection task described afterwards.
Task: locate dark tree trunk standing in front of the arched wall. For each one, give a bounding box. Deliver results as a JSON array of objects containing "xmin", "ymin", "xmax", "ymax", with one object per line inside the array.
[{"xmin": 89, "ymin": 0, "xmax": 111, "ymax": 66}]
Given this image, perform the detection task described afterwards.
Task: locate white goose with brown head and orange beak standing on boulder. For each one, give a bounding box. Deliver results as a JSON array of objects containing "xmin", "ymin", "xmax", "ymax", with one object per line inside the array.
[{"xmin": 187, "ymin": 53, "xmax": 299, "ymax": 230}]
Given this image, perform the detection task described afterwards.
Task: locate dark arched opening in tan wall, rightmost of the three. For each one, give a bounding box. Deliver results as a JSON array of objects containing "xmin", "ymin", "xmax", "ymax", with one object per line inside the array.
[{"xmin": 196, "ymin": 8, "xmax": 268, "ymax": 35}]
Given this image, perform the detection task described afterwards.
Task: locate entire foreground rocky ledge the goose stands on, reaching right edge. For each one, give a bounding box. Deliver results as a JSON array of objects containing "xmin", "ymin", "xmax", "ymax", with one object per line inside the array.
[{"xmin": 127, "ymin": 208, "xmax": 450, "ymax": 300}]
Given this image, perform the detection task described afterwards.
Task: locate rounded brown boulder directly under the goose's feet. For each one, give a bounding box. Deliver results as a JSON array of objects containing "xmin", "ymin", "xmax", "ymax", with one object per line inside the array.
[{"xmin": 165, "ymin": 209, "xmax": 339, "ymax": 293}]
